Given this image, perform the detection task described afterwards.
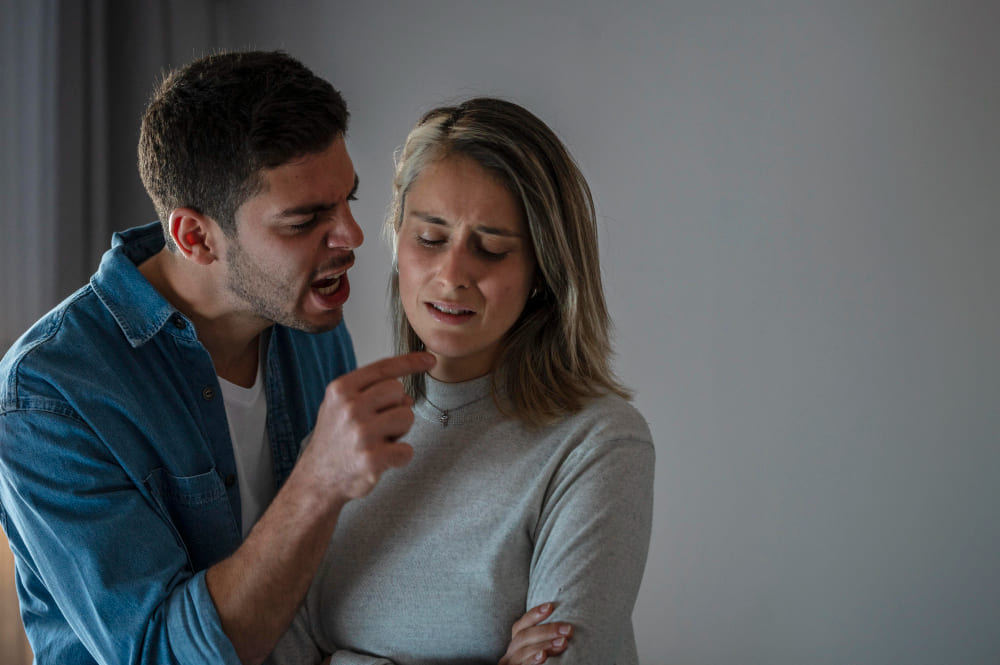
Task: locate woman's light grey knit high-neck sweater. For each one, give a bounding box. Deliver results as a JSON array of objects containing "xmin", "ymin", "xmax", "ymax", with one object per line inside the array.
[{"xmin": 269, "ymin": 377, "xmax": 654, "ymax": 665}]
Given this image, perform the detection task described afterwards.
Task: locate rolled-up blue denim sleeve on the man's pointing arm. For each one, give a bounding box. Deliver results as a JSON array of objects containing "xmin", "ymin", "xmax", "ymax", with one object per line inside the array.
[{"xmin": 0, "ymin": 403, "xmax": 239, "ymax": 665}]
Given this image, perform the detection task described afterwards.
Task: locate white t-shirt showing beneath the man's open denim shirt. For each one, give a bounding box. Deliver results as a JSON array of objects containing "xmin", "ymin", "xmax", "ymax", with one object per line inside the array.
[{"xmin": 219, "ymin": 350, "xmax": 274, "ymax": 538}]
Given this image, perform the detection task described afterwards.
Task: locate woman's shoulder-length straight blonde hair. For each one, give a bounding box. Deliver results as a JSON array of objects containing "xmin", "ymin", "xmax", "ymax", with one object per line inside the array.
[{"xmin": 385, "ymin": 97, "xmax": 630, "ymax": 425}]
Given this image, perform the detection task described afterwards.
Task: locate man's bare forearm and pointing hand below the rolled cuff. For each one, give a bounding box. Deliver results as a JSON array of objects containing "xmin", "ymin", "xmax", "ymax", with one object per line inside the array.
[{"xmin": 205, "ymin": 353, "xmax": 433, "ymax": 665}]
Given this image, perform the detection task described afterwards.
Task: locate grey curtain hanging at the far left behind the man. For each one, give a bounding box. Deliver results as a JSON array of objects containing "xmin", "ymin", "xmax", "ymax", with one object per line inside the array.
[{"xmin": 0, "ymin": 0, "xmax": 108, "ymax": 349}]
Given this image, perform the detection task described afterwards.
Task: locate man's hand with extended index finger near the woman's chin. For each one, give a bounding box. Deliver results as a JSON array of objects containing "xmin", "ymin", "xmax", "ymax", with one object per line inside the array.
[{"xmin": 297, "ymin": 352, "xmax": 434, "ymax": 502}]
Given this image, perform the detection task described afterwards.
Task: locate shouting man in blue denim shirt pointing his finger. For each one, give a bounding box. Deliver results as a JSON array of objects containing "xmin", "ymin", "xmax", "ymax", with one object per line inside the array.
[{"xmin": 0, "ymin": 52, "xmax": 433, "ymax": 665}]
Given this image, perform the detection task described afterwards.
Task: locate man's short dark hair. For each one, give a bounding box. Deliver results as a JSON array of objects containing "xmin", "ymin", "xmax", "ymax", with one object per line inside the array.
[{"xmin": 139, "ymin": 51, "xmax": 348, "ymax": 247}]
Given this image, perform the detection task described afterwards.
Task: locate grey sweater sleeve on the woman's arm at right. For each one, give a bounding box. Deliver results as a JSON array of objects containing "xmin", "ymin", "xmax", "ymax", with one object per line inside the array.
[{"xmin": 528, "ymin": 439, "xmax": 655, "ymax": 665}]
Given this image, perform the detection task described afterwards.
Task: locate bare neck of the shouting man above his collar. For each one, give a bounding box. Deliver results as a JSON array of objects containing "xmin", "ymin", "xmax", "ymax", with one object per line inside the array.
[{"xmin": 139, "ymin": 248, "xmax": 266, "ymax": 388}]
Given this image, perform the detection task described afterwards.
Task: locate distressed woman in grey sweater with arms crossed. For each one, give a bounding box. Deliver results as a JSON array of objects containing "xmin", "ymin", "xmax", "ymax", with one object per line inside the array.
[{"xmin": 277, "ymin": 98, "xmax": 654, "ymax": 665}]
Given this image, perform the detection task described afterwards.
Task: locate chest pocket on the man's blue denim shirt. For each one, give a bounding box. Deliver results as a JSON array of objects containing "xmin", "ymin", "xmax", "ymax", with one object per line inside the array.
[{"xmin": 145, "ymin": 468, "xmax": 241, "ymax": 571}]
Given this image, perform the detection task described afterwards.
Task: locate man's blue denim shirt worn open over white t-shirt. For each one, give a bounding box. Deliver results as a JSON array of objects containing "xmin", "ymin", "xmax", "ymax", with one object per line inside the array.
[{"xmin": 0, "ymin": 223, "xmax": 356, "ymax": 665}]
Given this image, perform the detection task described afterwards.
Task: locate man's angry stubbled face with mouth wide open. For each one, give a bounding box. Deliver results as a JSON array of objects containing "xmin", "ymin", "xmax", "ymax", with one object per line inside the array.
[{"xmin": 225, "ymin": 137, "xmax": 364, "ymax": 332}]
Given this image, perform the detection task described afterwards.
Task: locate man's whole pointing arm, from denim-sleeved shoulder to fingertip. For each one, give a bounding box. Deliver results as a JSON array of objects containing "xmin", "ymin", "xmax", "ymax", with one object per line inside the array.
[{"xmin": 0, "ymin": 356, "xmax": 430, "ymax": 664}]
